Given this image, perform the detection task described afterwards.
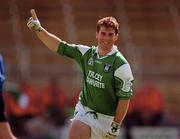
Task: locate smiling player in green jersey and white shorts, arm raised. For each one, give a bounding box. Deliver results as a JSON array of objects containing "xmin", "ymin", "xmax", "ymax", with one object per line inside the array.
[{"xmin": 27, "ymin": 10, "xmax": 133, "ymax": 139}]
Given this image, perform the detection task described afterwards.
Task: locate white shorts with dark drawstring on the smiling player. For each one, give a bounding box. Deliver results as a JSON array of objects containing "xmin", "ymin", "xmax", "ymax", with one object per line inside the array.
[{"xmin": 71, "ymin": 102, "xmax": 114, "ymax": 139}]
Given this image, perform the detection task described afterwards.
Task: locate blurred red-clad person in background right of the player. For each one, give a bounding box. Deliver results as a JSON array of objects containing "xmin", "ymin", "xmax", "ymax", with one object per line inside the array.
[{"xmin": 131, "ymin": 85, "xmax": 164, "ymax": 126}]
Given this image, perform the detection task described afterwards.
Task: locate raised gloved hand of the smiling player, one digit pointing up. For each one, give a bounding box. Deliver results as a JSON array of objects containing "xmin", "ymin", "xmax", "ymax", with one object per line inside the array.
[{"xmin": 27, "ymin": 9, "xmax": 42, "ymax": 32}]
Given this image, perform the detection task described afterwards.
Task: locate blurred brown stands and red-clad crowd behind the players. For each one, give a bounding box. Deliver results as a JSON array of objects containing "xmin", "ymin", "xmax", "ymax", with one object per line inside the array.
[{"xmin": 0, "ymin": 0, "xmax": 180, "ymax": 139}]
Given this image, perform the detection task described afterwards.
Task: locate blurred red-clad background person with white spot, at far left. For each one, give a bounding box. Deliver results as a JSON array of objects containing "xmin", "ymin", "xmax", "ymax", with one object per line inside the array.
[{"xmin": 4, "ymin": 77, "xmax": 41, "ymax": 137}]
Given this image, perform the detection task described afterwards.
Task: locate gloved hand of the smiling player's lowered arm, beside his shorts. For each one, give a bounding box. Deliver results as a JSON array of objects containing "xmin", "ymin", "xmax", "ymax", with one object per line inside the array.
[{"xmin": 105, "ymin": 121, "xmax": 120, "ymax": 139}]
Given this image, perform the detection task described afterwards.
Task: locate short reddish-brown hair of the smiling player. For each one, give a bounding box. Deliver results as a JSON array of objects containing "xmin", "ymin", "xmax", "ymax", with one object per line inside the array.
[{"xmin": 96, "ymin": 17, "xmax": 119, "ymax": 34}]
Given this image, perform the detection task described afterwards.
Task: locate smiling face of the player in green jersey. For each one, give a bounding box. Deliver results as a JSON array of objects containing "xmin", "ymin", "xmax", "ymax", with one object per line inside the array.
[{"xmin": 96, "ymin": 26, "xmax": 118, "ymax": 50}]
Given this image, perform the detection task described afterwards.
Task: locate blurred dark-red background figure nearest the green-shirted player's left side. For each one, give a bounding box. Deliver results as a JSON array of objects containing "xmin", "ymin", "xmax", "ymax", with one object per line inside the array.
[{"xmin": 40, "ymin": 77, "xmax": 68, "ymax": 126}]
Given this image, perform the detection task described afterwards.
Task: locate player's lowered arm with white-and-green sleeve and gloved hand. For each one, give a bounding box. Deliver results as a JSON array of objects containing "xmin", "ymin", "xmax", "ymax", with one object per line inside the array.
[{"xmin": 106, "ymin": 64, "xmax": 134, "ymax": 139}]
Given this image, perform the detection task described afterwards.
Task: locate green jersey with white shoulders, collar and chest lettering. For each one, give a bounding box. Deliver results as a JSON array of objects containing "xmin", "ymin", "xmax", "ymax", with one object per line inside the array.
[{"xmin": 57, "ymin": 41, "xmax": 133, "ymax": 116}]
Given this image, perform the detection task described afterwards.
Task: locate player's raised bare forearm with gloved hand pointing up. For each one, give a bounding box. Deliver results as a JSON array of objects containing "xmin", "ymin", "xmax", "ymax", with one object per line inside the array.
[{"xmin": 27, "ymin": 9, "xmax": 61, "ymax": 52}]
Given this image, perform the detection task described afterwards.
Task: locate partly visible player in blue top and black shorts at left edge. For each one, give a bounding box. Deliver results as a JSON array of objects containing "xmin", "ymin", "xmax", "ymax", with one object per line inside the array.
[{"xmin": 0, "ymin": 54, "xmax": 16, "ymax": 139}]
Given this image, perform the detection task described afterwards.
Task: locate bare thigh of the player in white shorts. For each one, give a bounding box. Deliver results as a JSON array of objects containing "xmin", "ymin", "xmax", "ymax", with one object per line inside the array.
[{"xmin": 68, "ymin": 120, "xmax": 91, "ymax": 139}]
